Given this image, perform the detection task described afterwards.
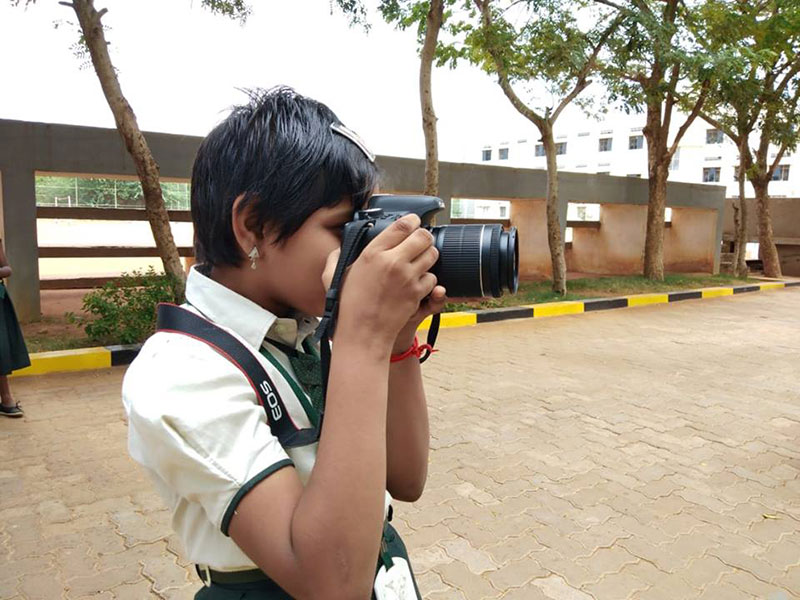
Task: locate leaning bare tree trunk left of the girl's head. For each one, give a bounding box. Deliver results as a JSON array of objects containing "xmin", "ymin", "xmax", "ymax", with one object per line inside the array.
[{"xmin": 72, "ymin": 0, "xmax": 185, "ymax": 299}]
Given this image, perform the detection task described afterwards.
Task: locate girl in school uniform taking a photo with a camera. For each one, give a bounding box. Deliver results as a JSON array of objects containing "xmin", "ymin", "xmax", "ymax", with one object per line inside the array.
[{"xmin": 123, "ymin": 88, "xmax": 445, "ymax": 599}]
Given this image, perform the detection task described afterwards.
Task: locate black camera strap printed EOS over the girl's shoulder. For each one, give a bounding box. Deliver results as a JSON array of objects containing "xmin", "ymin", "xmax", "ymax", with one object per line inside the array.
[{"xmin": 156, "ymin": 303, "xmax": 320, "ymax": 448}]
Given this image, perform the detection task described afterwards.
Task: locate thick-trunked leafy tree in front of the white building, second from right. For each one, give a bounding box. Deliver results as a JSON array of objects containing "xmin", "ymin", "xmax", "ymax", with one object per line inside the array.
[{"xmin": 595, "ymin": 0, "xmax": 724, "ymax": 280}]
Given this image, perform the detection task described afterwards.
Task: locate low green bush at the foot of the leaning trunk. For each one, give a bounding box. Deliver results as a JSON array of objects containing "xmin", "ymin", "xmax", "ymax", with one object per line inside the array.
[{"xmin": 66, "ymin": 267, "xmax": 180, "ymax": 345}]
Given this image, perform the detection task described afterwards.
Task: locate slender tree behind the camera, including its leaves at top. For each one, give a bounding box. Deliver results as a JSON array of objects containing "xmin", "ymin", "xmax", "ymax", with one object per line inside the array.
[{"xmin": 378, "ymin": 0, "xmax": 446, "ymax": 196}]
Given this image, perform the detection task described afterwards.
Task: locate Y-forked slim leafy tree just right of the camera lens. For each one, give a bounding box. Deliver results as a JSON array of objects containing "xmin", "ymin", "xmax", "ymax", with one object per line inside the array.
[{"xmin": 462, "ymin": 0, "xmax": 621, "ymax": 295}]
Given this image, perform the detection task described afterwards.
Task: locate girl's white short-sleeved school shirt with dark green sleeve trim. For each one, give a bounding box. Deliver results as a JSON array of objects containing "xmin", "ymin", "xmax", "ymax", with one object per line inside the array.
[{"xmin": 122, "ymin": 267, "xmax": 391, "ymax": 571}]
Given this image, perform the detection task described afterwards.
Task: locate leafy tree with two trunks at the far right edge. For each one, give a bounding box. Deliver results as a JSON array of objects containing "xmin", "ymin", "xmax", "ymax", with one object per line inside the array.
[{"xmin": 701, "ymin": 0, "xmax": 800, "ymax": 277}]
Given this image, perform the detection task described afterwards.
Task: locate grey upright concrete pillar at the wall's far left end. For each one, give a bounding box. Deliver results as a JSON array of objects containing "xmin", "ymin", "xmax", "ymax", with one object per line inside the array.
[{"xmin": 0, "ymin": 168, "xmax": 41, "ymax": 322}]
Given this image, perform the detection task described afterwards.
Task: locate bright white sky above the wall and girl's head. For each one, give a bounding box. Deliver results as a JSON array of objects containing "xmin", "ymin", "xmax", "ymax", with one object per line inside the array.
[{"xmin": 0, "ymin": 0, "xmax": 538, "ymax": 161}]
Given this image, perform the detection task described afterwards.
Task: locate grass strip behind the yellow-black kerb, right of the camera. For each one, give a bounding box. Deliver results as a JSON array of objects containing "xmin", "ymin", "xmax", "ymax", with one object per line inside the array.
[{"xmin": 445, "ymin": 275, "xmax": 748, "ymax": 312}]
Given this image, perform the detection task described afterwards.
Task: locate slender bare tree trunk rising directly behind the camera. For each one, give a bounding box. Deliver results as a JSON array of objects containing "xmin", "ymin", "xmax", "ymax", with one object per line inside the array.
[{"xmin": 419, "ymin": 0, "xmax": 444, "ymax": 196}]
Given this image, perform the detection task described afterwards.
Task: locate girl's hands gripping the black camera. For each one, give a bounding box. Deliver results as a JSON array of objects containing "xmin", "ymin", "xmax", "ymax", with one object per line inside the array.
[{"xmin": 323, "ymin": 215, "xmax": 445, "ymax": 350}]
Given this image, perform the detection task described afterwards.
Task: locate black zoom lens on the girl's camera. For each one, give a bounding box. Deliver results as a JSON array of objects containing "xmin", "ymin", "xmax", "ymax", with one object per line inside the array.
[{"xmin": 431, "ymin": 225, "xmax": 519, "ymax": 298}]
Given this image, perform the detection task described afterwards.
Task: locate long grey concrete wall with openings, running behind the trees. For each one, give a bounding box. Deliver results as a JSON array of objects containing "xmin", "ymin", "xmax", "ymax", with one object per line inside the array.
[{"xmin": 0, "ymin": 120, "xmax": 724, "ymax": 320}]
